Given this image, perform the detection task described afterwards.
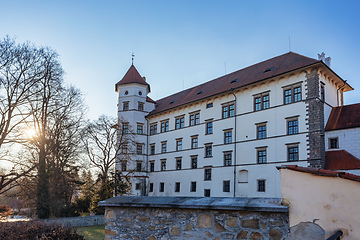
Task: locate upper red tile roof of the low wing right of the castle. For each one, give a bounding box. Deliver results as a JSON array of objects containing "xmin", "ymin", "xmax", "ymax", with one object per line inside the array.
[{"xmin": 325, "ymin": 103, "xmax": 360, "ymax": 131}]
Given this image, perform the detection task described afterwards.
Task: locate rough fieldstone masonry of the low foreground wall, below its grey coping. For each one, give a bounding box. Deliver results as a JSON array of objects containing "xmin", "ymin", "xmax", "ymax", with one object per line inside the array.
[{"xmin": 105, "ymin": 207, "xmax": 289, "ymax": 240}]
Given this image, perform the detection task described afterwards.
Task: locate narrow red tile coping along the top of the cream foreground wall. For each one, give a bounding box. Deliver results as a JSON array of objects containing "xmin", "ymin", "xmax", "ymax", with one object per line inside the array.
[{"xmin": 276, "ymin": 165, "xmax": 360, "ymax": 182}]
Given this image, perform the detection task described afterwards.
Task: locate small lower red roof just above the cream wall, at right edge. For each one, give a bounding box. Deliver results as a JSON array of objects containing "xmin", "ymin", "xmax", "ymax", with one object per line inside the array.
[{"xmin": 325, "ymin": 150, "xmax": 360, "ymax": 170}]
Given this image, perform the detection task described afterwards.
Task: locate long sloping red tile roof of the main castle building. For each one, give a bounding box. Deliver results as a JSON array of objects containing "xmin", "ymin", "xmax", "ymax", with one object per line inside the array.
[{"xmin": 149, "ymin": 52, "xmax": 325, "ymax": 116}]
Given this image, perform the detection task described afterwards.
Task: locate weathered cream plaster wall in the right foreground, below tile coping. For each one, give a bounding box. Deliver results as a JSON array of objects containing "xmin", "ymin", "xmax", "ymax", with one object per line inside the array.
[{"xmin": 280, "ymin": 169, "xmax": 360, "ymax": 240}]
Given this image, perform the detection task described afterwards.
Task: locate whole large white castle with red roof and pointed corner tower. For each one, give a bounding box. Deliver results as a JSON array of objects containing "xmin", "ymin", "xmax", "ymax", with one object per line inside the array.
[{"xmin": 116, "ymin": 52, "xmax": 353, "ymax": 197}]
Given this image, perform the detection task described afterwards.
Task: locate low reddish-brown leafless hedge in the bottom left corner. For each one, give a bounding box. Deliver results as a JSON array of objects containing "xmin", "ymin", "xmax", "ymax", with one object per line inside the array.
[{"xmin": 0, "ymin": 221, "xmax": 85, "ymax": 240}]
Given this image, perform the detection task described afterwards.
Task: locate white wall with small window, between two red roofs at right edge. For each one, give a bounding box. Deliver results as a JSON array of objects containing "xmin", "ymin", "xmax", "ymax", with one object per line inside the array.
[{"xmin": 325, "ymin": 128, "xmax": 360, "ymax": 159}]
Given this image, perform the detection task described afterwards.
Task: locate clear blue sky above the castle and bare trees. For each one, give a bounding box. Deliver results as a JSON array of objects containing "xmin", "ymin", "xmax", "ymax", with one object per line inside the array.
[{"xmin": 0, "ymin": 0, "xmax": 360, "ymax": 119}]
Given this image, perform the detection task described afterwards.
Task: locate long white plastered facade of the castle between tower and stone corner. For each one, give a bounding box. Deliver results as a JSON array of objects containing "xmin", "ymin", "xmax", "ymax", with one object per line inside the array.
[{"xmin": 149, "ymin": 73, "xmax": 308, "ymax": 197}]
